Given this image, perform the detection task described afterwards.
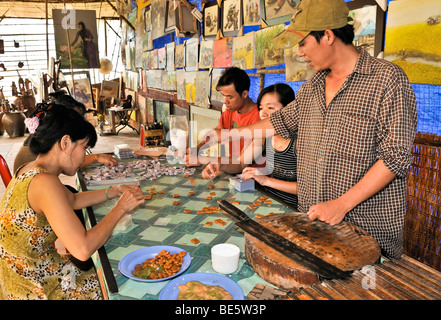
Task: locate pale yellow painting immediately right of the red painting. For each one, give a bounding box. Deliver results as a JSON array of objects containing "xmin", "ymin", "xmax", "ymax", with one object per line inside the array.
[{"xmin": 233, "ymin": 31, "xmax": 255, "ymax": 70}]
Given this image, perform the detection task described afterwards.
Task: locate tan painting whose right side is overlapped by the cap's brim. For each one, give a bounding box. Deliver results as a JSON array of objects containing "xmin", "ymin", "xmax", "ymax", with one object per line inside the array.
[{"xmin": 254, "ymin": 24, "xmax": 285, "ymax": 68}]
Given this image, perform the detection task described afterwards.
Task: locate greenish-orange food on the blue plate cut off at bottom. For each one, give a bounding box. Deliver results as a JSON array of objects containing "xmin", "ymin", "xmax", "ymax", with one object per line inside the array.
[{"xmin": 178, "ymin": 281, "xmax": 233, "ymax": 300}]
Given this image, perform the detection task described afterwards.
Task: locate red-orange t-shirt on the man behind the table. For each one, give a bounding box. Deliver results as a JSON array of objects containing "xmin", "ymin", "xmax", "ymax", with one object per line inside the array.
[{"xmin": 219, "ymin": 105, "xmax": 260, "ymax": 157}]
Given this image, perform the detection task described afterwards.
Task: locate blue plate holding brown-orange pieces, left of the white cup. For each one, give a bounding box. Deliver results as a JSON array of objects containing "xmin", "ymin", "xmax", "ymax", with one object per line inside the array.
[{"xmin": 118, "ymin": 246, "xmax": 191, "ymax": 282}]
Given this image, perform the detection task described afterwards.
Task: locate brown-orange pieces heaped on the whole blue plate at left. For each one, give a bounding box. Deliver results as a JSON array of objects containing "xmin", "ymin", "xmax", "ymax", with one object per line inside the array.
[{"xmin": 132, "ymin": 250, "xmax": 187, "ymax": 280}]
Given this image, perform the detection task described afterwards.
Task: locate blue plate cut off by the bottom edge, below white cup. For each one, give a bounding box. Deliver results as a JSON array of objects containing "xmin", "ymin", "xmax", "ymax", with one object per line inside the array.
[{"xmin": 159, "ymin": 272, "xmax": 244, "ymax": 300}]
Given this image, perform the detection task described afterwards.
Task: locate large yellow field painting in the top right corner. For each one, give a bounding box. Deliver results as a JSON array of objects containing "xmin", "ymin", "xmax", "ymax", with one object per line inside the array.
[{"xmin": 384, "ymin": 0, "xmax": 441, "ymax": 85}]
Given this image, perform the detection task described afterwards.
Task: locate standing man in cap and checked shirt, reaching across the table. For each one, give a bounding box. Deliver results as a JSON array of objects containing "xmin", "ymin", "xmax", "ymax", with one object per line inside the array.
[{"xmin": 205, "ymin": 0, "xmax": 417, "ymax": 258}]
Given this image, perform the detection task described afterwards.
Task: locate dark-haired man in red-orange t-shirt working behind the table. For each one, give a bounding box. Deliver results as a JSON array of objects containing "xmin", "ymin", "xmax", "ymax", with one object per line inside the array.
[{"xmin": 186, "ymin": 67, "xmax": 260, "ymax": 166}]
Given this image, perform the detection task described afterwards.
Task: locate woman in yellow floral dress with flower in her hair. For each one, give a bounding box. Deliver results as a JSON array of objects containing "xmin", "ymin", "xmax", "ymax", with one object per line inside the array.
[{"xmin": 0, "ymin": 104, "xmax": 144, "ymax": 300}]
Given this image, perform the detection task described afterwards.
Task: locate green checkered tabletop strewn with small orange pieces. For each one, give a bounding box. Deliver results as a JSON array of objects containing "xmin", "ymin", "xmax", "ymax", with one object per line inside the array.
[{"xmin": 78, "ymin": 159, "xmax": 292, "ymax": 300}]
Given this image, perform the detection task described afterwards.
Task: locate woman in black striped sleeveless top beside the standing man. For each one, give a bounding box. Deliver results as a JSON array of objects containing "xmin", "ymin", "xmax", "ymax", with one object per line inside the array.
[{"xmin": 202, "ymin": 83, "xmax": 297, "ymax": 210}]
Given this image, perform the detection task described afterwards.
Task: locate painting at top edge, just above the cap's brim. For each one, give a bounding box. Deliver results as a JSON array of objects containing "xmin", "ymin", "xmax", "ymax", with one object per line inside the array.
[{"xmin": 260, "ymin": 0, "xmax": 301, "ymax": 26}]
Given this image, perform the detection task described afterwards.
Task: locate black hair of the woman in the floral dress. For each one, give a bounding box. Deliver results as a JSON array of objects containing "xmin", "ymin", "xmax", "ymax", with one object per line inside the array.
[{"xmin": 29, "ymin": 104, "xmax": 97, "ymax": 154}]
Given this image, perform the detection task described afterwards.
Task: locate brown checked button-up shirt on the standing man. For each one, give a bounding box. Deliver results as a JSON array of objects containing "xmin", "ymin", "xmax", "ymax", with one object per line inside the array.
[{"xmin": 270, "ymin": 49, "xmax": 417, "ymax": 257}]
